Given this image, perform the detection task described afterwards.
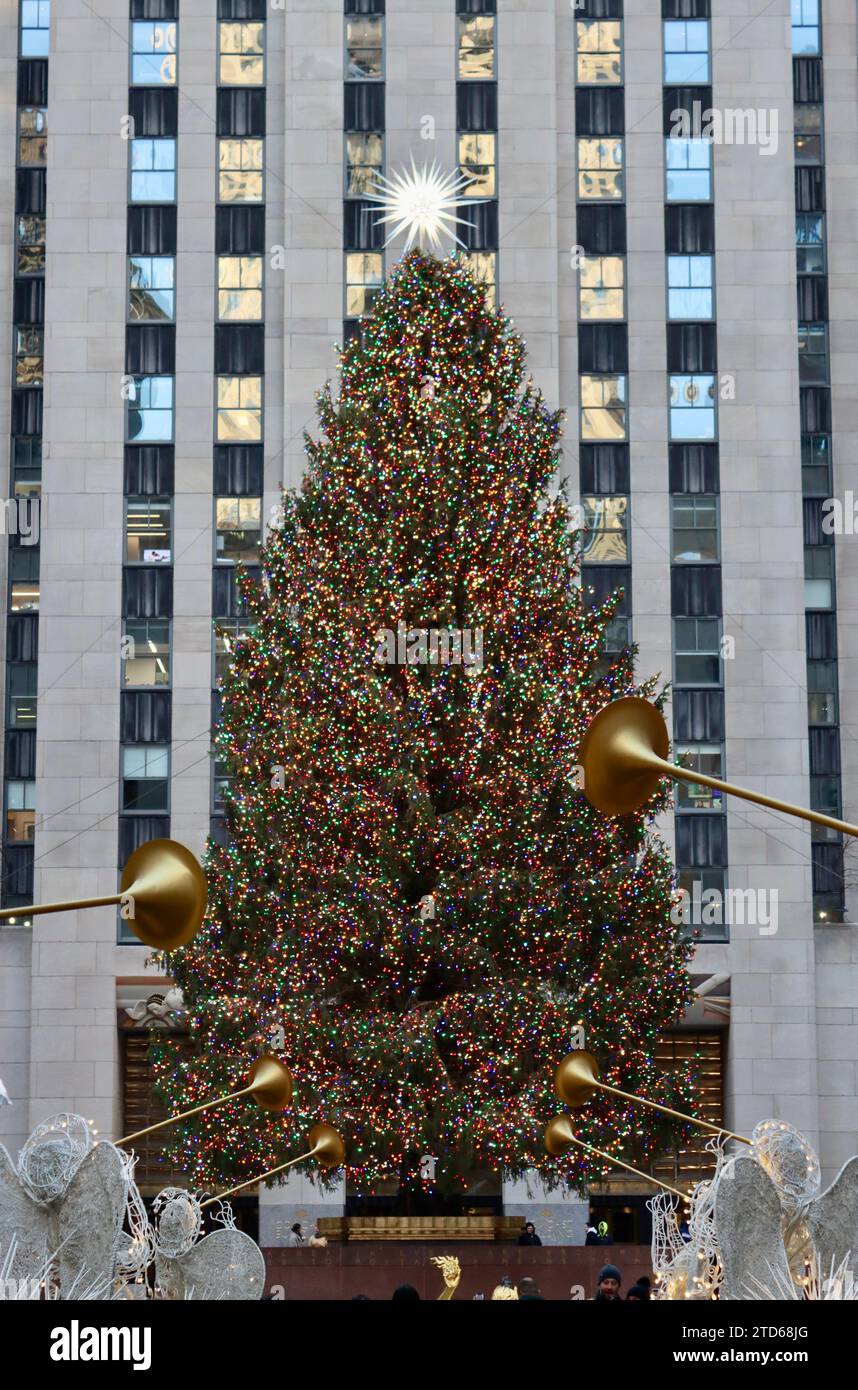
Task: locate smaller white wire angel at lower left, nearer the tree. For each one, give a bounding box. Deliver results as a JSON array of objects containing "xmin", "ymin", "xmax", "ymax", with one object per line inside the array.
[{"xmin": 152, "ymin": 1187, "xmax": 266, "ymax": 1302}]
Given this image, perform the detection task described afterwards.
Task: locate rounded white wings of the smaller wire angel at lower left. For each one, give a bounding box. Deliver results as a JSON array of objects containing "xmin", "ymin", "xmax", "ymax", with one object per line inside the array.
[{"xmin": 156, "ymin": 1229, "xmax": 266, "ymax": 1302}]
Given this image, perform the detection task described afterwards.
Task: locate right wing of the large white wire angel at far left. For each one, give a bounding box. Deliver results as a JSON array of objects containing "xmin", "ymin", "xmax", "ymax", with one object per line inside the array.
[{"xmin": 54, "ymin": 1144, "xmax": 129, "ymax": 1297}]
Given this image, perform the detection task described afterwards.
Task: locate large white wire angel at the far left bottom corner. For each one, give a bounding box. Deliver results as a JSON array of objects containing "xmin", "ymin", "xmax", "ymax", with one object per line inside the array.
[{"xmin": 0, "ymin": 1113, "xmax": 152, "ymax": 1300}]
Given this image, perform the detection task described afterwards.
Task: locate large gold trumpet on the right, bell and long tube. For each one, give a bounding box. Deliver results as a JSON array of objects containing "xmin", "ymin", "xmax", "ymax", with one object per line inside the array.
[{"xmin": 578, "ymin": 695, "xmax": 858, "ymax": 835}]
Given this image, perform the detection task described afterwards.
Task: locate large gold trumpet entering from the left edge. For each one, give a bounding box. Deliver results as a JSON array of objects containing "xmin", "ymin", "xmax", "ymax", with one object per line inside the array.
[{"xmin": 0, "ymin": 840, "xmax": 206, "ymax": 951}]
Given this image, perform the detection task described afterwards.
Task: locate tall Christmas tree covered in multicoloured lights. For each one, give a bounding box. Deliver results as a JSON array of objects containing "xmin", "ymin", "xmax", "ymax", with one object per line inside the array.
[{"xmin": 156, "ymin": 252, "xmax": 694, "ymax": 1191}]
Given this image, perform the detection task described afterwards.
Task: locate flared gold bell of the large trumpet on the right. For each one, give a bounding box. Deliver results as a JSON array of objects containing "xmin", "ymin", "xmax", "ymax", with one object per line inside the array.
[{"xmin": 578, "ymin": 695, "xmax": 670, "ymax": 816}]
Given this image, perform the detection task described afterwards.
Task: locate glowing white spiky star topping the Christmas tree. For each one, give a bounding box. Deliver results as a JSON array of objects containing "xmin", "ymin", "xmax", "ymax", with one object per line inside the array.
[{"xmin": 366, "ymin": 156, "xmax": 485, "ymax": 252}]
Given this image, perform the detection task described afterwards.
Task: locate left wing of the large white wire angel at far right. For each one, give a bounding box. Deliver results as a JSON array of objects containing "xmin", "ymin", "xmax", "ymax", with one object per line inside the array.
[{"xmin": 715, "ymin": 1156, "xmax": 791, "ymax": 1300}]
